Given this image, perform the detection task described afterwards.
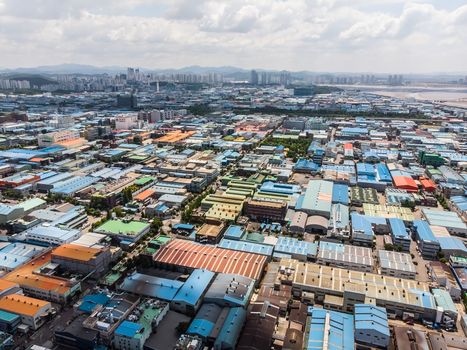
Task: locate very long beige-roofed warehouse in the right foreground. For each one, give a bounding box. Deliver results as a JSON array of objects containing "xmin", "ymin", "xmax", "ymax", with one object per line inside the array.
[{"xmin": 276, "ymin": 259, "xmax": 436, "ymax": 322}]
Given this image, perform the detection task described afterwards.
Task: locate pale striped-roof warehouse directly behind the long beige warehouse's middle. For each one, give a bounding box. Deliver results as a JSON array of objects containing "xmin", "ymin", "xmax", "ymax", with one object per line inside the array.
[{"xmin": 316, "ymin": 241, "xmax": 374, "ymax": 272}]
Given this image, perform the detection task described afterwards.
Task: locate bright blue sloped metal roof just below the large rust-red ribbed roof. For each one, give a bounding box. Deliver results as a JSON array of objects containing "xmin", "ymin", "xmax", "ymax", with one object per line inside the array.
[{"xmin": 173, "ymin": 269, "xmax": 215, "ymax": 305}]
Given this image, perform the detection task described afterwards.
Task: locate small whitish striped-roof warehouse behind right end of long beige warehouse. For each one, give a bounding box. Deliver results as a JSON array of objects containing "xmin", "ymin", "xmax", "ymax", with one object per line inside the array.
[{"xmin": 378, "ymin": 250, "xmax": 417, "ymax": 279}]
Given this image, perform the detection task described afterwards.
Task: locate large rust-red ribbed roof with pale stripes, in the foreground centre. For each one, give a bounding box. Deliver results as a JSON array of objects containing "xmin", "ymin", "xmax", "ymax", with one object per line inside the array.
[{"xmin": 154, "ymin": 239, "xmax": 266, "ymax": 280}]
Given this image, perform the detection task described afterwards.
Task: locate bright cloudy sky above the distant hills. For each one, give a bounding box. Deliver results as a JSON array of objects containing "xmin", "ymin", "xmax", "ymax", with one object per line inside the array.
[{"xmin": 0, "ymin": 0, "xmax": 467, "ymax": 73}]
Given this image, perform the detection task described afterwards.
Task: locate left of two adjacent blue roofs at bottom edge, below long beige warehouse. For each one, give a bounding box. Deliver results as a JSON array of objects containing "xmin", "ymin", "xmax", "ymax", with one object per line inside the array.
[{"xmin": 305, "ymin": 307, "xmax": 355, "ymax": 350}]
